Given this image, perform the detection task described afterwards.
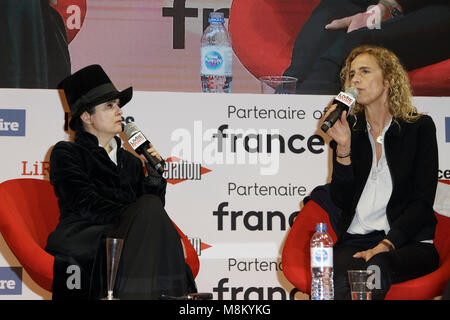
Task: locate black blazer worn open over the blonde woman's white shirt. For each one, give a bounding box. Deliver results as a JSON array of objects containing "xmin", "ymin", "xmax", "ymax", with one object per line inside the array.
[{"xmin": 330, "ymin": 114, "xmax": 438, "ymax": 248}]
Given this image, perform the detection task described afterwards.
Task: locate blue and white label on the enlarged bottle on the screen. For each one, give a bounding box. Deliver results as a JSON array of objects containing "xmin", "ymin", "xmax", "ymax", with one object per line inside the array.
[{"xmin": 200, "ymin": 46, "xmax": 233, "ymax": 76}]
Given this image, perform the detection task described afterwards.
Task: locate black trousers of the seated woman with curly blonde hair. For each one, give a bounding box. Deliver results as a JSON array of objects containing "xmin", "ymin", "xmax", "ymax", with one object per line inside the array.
[{"xmin": 333, "ymin": 231, "xmax": 439, "ymax": 300}]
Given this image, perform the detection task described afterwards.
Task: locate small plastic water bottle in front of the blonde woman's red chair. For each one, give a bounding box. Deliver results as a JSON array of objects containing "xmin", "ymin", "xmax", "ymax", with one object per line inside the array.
[{"xmin": 310, "ymin": 223, "xmax": 334, "ymax": 300}]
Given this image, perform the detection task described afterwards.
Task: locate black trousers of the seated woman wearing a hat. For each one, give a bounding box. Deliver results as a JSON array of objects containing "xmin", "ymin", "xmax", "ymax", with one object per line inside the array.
[{"xmin": 108, "ymin": 195, "xmax": 197, "ymax": 300}]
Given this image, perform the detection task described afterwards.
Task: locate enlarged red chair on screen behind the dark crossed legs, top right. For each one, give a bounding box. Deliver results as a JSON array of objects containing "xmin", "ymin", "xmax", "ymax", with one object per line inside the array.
[{"xmin": 228, "ymin": 0, "xmax": 450, "ymax": 96}]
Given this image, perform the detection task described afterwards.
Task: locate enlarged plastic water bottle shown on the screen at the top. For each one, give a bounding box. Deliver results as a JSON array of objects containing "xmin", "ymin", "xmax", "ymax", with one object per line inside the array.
[{"xmin": 200, "ymin": 12, "xmax": 233, "ymax": 93}]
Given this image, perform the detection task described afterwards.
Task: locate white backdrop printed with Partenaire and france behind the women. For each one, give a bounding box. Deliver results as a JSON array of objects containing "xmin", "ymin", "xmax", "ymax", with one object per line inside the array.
[{"xmin": 0, "ymin": 89, "xmax": 450, "ymax": 299}]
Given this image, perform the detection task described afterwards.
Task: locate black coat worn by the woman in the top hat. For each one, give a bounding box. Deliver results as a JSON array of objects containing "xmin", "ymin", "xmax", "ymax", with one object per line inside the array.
[{"xmin": 46, "ymin": 132, "xmax": 167, "ymax": 298}]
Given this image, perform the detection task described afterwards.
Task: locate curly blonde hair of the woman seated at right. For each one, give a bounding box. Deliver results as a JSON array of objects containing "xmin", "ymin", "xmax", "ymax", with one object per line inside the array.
[{"xmin": 340, "ymin": 45, "xmax": 422, "ymax": 122}]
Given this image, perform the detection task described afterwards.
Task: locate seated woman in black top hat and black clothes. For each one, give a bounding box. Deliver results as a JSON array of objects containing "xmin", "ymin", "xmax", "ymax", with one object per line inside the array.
[{"xmin": 46, "ymin": 65, "xmax": 196, "ymax": 299}]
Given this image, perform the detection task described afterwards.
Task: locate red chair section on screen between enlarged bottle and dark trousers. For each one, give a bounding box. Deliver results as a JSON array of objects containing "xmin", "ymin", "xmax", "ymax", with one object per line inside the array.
[{"xmin": 228, "ymin": 0, "xmax": 320, "ymax": 78}]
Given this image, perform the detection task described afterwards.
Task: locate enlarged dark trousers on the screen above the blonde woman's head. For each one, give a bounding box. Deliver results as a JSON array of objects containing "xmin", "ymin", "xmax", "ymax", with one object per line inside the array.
[{"xmin": 284, "ymin": 0, "xmax": 450, "ymax": 94}]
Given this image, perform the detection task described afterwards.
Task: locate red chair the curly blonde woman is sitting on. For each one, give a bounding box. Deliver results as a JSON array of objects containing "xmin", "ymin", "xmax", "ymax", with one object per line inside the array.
[{"xmin": 281, "ymin": 188, "xmax": 450, "ymax": 300}]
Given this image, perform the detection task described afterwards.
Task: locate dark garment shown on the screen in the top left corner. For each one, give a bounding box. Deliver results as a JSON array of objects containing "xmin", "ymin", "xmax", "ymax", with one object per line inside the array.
[{"xmin": 0, "ymin": 0, "xmax": 71, "ymax": 89}]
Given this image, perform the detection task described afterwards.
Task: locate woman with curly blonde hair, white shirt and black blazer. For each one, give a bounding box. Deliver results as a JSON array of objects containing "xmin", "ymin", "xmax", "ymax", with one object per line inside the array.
[{"xmin": 324, "ymin": 46, "xmax": 439, "ymax": 299}]
